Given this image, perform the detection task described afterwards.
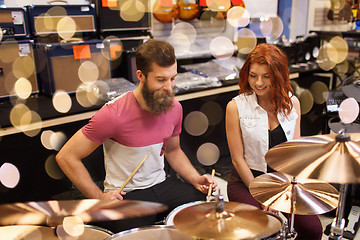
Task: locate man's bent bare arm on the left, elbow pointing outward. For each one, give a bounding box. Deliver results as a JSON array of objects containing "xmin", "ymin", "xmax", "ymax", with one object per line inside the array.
[{"xmin": 56, "ymin": 130, "xmax": 122, "ymax": 200}]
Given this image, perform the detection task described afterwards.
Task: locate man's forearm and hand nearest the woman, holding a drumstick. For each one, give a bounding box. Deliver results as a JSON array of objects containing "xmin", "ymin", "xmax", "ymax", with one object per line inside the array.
[{"xmin": 165, "ymin": 136, "xmax": 216, "ymax": 193}]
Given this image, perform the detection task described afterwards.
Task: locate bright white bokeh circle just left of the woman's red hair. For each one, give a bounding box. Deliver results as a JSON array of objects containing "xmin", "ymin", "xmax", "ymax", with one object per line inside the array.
[{"xmin": 209, "ymin": 36, "xmax": 235, "ymax": 59}]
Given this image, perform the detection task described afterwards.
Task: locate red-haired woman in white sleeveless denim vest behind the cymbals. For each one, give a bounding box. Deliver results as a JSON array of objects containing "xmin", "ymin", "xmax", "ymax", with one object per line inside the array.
[{"xmin": 226, "ymin": 43, "xmax": 322, "ymax": 240}]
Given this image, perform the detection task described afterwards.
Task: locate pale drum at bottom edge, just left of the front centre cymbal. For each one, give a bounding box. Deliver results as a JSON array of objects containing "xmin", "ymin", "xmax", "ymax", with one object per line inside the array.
[{"xmin": 106, "ymin": 225, "xmax": 195, "ymax": 240}]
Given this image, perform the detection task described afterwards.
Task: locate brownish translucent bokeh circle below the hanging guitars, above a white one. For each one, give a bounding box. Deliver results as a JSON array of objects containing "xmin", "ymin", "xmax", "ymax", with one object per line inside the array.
[{"xmin": 199, "ymin": 11, "xmax": 226, "ymax": 37}]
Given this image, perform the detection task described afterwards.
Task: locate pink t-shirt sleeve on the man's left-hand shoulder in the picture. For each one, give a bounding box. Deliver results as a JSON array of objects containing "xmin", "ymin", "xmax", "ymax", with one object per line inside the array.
[{"xmin": 81, "ymin": 105, "xmax": 116, "ymax": 144}]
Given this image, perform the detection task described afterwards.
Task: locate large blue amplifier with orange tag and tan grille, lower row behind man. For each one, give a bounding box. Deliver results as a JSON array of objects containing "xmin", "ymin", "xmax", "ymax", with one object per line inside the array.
[{"xmin": 35, "ymin": 40, "xmax": 122, "ymax": 95}]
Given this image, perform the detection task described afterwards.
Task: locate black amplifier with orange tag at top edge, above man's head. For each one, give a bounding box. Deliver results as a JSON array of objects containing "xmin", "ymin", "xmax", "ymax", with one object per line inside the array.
[{"xmin": 92, "ymin": 0, "xmax": 151, "ymax": 33}]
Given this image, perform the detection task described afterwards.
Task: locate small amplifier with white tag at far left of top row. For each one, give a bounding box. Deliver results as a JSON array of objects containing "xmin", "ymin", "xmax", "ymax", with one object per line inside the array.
[{"xmin": 0, "ymin": 8, "xmax": 30, "ymax": 40}]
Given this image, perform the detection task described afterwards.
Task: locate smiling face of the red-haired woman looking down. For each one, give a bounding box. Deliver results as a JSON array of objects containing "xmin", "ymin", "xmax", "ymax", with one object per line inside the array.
[{"xmin": 248, "ymin": 63, "xmax": 271, "ymax": 96}]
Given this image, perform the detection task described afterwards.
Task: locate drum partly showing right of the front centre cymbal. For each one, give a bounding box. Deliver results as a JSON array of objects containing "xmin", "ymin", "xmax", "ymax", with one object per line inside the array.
[{"xmin": 259, "ymin": 211, "xmax": 286, "ymax": 240}]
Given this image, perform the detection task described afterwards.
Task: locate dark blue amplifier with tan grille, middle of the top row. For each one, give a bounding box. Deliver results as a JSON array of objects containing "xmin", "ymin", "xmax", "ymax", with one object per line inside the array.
[{"xmin": 28, "ymin": 4, "xmax": 96, "ymax": 36}]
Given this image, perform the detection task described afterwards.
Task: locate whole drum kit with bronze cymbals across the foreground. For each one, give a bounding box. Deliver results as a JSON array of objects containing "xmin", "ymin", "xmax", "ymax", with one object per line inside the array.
[{"xmin": 0, "ymin": 133, "xmax": 360, "ymax": 240}]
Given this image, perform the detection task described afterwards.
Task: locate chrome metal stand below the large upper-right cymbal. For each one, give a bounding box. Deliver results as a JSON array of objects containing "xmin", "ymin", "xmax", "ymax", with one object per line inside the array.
[{"xmin": 329, "ymin": 184, "xmax": 348, "ymax": 240}]
